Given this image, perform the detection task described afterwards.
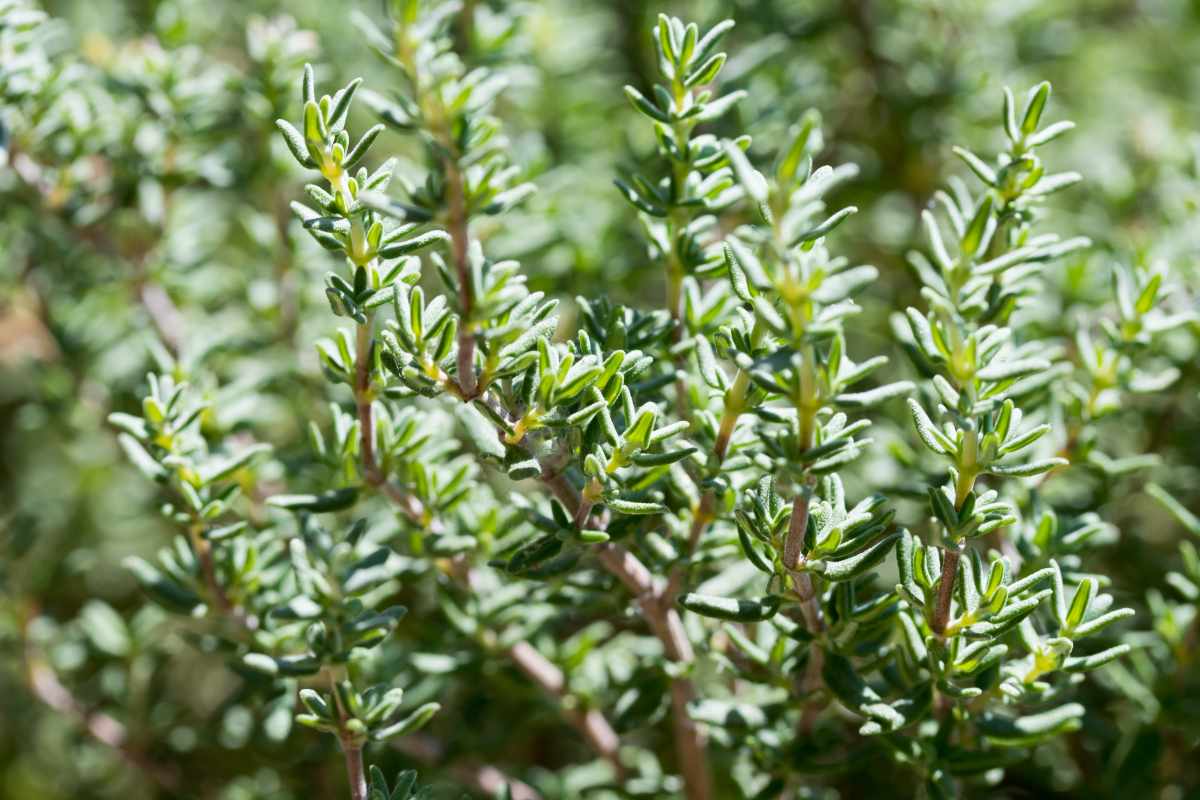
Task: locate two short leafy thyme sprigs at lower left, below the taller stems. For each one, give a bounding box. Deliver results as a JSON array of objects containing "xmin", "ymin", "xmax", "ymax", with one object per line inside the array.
[{"xmin": 110, "ymin": 374, "xmax": 437, "ymax": 745}]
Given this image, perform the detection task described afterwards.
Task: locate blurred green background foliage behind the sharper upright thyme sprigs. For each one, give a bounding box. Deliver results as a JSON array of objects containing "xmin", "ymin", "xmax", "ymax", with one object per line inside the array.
[{"xmin": 0, "ymin": 0, "xmax": 1200, "ymax": 800}]
